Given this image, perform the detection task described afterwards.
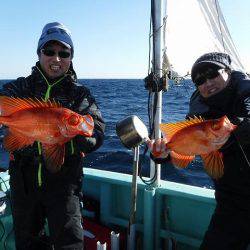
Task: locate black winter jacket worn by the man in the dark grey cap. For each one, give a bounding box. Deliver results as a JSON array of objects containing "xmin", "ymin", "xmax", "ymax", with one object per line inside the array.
[{"xmin": 188, "ymin": 71, "xmax": 250, "ymax": 211}]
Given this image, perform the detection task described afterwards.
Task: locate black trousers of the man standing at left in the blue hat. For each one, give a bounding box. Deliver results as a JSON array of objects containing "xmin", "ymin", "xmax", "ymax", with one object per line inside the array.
[{"xmin": 10, "ymin": 166, "xmax": 83, "ymax": 250}]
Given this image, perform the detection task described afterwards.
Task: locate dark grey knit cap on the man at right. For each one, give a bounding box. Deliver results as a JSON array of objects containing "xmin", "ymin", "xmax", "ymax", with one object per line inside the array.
[{"xmin": 191, "ymin": 52, "xmax": 231, "ymax": 81}]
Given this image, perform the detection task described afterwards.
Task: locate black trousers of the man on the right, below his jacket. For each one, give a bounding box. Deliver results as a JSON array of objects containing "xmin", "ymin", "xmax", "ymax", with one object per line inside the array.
[{"xmin": 200, "ymin": 206, "xmax": 250, "ymax": 250}]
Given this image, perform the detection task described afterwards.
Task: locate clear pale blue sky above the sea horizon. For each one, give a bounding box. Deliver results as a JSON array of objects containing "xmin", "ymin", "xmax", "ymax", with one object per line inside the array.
[{"xmin": 0, "ymin": 0, "xmax": 250, "ymax": 79}]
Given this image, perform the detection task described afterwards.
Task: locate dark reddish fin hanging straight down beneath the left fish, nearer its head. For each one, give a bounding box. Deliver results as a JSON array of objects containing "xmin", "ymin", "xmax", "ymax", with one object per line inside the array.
[{"xmin": 43, "ymin": 144, "xmax": 65, "ymax": 173}]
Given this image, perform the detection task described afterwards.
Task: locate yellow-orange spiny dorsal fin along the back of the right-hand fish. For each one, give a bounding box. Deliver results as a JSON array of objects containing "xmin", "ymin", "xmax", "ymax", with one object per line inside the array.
[{"xmin": 160, "ymin": 116, "xmax": 204, "ymax": 140}]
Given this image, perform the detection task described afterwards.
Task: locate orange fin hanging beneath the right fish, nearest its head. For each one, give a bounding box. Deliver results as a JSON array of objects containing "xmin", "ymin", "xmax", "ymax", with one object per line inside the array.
[{"xmin": 201, "ymin": 151, "xmax": 224, "ymax": 179}]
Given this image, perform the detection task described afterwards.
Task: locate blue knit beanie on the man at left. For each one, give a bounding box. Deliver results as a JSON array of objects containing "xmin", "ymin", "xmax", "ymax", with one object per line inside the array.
[{"xmin": 37, "ymin": 22, "xmax": 74, "ymax": 57}]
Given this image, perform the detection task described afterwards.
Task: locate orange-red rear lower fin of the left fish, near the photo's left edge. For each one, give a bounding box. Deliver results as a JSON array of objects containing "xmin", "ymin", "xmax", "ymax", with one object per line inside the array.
[{"xmin": 3, "ymin": 130, "xmax": 34, "ymax": 152}]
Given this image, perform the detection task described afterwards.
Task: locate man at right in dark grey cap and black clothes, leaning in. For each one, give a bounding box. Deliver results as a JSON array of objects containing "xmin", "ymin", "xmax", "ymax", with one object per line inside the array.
[{"xmin": 148, "ymin": 52, "xmax": 250, "ymax": 250}]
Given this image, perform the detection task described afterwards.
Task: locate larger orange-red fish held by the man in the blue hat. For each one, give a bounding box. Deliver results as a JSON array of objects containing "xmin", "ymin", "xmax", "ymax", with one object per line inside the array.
[{"xmin": 0, "ymin": 96, "xmax": 94, "ymax": 172}]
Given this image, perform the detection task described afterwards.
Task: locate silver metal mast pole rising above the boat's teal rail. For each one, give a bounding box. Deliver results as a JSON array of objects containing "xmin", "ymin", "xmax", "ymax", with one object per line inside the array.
[{"xmin": 150, "ymin": 0, "xmax": 163, "ymax": 186}]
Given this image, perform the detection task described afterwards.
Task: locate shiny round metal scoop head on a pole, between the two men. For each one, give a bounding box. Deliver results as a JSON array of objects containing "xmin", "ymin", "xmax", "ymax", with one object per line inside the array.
[{"xmin": 116, "ymin": 115, "xmax": 148, "ymax": 149}]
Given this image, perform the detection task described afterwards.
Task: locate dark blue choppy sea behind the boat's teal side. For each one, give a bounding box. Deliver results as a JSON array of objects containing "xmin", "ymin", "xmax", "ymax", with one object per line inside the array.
[{"xmin": 0, "ymin": 79, "xmax": 213, "ymax": 188}]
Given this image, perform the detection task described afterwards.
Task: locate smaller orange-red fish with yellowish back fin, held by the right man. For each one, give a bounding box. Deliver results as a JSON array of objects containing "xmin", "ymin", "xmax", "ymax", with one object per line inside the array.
[{"xmin": 160, "ymin": 116, "xmax": 237, "ymax": 179}]
